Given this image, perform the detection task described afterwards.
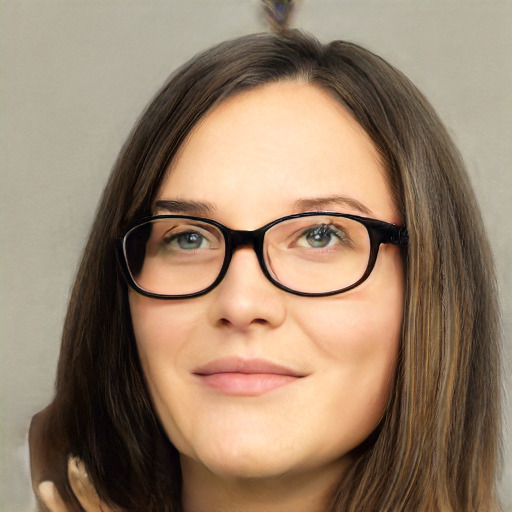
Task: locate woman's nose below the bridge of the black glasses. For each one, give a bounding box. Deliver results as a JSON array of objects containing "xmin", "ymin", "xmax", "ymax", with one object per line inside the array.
[{"xmin": 209, "ymin": 246, "xmax": 287, "ymax": 331}]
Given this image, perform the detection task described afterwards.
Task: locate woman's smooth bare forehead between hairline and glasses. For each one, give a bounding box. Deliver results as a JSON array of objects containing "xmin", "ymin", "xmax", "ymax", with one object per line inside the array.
[{"xmin": 158, "ymin": 82, "xmax": 398, "ymax": 229}]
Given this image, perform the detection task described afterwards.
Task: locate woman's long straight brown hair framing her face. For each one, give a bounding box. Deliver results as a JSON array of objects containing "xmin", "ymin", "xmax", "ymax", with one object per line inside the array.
[{"xmin": 34, "ymin": 30, "xmax": 500, "ymax": 512}]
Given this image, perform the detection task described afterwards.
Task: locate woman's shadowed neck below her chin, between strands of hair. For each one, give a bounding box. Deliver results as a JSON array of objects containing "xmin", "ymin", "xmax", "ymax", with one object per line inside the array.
[{"xmin": 182, "ymin": 458, "xmax": 346, "ymax": 512}]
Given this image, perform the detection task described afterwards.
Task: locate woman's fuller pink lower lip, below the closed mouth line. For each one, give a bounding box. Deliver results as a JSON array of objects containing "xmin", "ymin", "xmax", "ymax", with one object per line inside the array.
[{"xmin": 199, "ymin": 373, "xmax": 298, "ymax": 396}]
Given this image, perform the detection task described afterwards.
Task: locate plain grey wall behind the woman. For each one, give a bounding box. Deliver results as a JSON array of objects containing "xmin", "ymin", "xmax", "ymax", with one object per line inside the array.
[{"xmin": 0, "ymin": 0, "xmax": 512, "ymax": 512}]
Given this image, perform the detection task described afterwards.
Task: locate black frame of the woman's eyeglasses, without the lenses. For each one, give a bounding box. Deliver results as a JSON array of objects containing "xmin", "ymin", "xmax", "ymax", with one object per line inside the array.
[{"xmin": 117, "ymin": 211, "xmax": 409, "ymax": 300}]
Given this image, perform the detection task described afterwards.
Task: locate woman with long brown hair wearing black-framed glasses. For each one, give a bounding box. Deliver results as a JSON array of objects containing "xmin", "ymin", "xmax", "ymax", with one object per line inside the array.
[{"xmin": 31, "ymin": 31, "xmax": 499, "ymax": 512}]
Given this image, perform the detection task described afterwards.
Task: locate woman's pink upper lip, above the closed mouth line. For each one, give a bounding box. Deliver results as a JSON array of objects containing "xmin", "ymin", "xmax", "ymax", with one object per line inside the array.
[{"xmin": 193, "ymin": 357, "xmax": 305, "ymax": 377}]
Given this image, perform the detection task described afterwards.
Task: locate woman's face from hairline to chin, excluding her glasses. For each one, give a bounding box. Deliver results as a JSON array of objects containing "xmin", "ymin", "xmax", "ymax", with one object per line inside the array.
[{"xmin": 130, "ymin": 82, "xmax": 403, "ymax": 486}]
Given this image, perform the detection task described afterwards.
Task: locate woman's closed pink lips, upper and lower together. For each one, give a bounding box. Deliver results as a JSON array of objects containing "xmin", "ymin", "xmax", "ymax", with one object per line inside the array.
[{"xmin": 193, "ymin": 357, "xmax": 305, "ymax": 396}]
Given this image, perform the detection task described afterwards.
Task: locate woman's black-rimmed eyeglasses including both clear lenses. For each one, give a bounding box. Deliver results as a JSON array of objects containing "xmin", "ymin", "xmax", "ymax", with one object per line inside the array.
[{"xmin": 119, "ymin": 212, "xmax": 408, "ymax": 299}]
